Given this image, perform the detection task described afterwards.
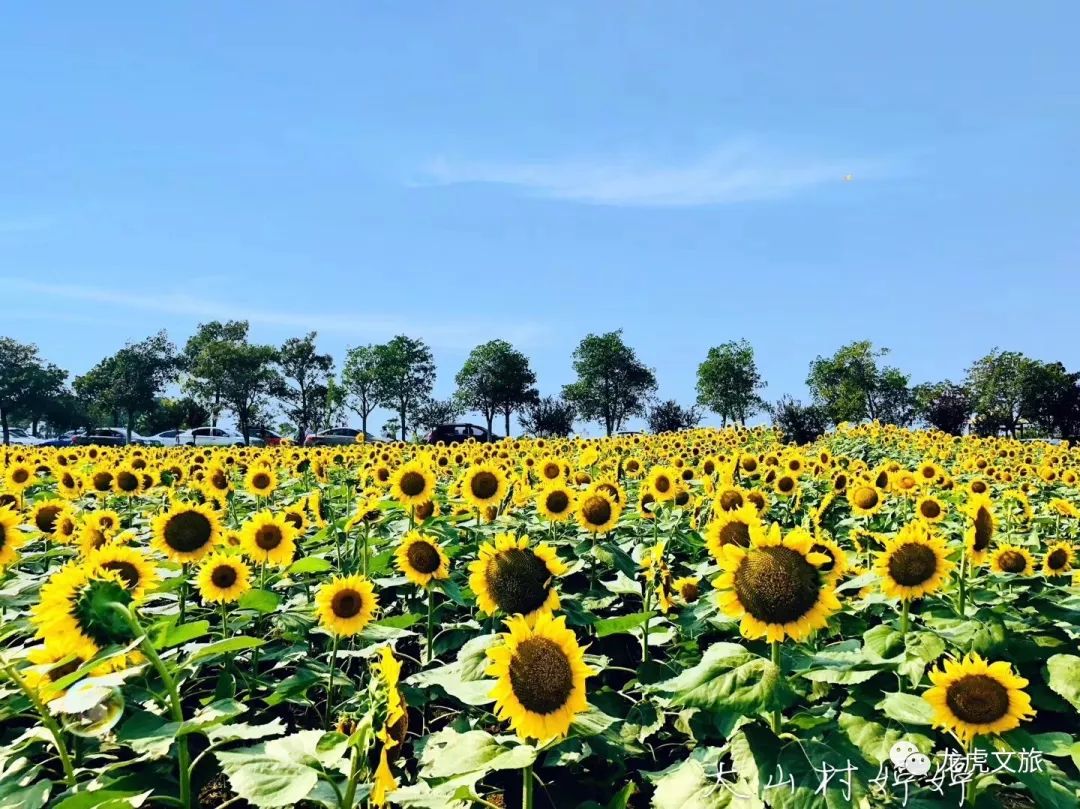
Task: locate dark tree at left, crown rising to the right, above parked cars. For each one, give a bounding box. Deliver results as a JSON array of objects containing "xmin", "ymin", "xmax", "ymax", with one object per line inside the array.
[{"xmin": 75, "ymin": 332, "xmax": 178, "ymax": 439}]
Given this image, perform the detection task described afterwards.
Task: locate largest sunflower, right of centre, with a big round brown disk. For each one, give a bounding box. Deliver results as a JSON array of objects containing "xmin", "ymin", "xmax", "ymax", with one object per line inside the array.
[{"xmin": 714, "ymin": 525, "xmax": 840, "ymax": 642}]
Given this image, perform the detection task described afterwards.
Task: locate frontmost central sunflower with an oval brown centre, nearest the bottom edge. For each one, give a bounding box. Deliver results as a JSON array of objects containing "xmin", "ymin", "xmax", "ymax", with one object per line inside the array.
[{"xmin": 485, "ymin": 615, "xmax": 595, "ymax": 740}]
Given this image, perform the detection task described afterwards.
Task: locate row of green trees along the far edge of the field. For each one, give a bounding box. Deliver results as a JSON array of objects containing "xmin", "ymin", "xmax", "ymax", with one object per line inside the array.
[{"xmin": 0, "ymin": 321, "xmax": 1080, "ymax": 443}]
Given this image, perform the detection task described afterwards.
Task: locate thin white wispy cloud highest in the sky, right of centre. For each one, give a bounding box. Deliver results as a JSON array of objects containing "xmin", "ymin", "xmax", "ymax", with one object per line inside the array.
[{"xmin": 421, "ymin": 140, "xmax": 890, "ymax": 207}]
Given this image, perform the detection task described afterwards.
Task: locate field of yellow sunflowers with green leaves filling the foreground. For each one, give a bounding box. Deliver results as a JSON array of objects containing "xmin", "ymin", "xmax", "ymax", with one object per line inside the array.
[{"xmin": 0, "ymin": 424, "xmax": 1080, "ymax": 809}]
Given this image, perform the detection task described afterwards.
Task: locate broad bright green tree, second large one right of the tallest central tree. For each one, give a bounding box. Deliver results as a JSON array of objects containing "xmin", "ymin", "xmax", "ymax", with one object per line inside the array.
[{"xmin": 807, "ymin": 340, "xmax": 914, "ymax": 424}]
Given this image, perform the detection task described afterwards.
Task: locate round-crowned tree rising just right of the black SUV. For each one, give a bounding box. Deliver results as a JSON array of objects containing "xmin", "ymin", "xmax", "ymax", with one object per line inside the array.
[{"xmin": 455, "ymin": 340, "xmax": 537, "ymax": 435}]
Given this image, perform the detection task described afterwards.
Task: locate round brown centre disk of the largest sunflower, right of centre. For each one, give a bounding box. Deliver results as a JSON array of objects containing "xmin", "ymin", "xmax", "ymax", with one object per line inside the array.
[{"xmin": 734, "ymin": 545, "xmax": 821, "ymax": 624}]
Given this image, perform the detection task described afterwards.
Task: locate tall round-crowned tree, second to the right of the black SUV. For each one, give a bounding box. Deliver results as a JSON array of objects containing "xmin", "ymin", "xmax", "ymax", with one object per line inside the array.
[{"xmin": 563, "ymin": 331, "xmax": 657, "ymax": 435}]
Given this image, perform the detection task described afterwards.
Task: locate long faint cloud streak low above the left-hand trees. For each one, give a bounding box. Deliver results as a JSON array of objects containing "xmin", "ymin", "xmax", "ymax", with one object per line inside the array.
[{"xmin": 0, "ymin": 278, "xmax": 545, "ymax": 349}]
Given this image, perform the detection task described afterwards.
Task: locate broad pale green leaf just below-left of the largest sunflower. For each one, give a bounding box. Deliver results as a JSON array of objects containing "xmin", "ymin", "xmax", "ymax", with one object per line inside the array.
[{"xmin": 646, "ymin": 643, "xmax": 796, "ymax": 714}]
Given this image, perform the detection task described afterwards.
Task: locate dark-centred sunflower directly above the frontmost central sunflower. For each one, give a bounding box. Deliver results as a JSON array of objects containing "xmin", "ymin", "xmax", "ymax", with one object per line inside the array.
[{"xmin": 469, "ymin": 534, "xmax": 567, "ymax": 621}]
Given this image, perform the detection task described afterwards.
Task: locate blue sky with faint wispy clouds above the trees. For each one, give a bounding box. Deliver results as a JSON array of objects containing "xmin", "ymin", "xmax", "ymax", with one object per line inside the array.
[{"xmin": 0, "ymin": 1, "xmax": 1080, "ymax": 436}]
